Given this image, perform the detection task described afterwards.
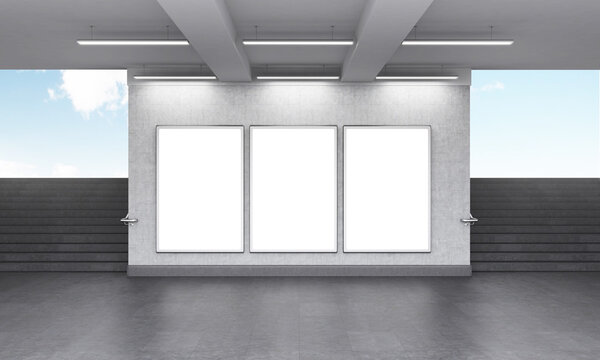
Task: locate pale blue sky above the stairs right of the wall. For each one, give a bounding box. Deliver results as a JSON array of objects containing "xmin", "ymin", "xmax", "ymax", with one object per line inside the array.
[{"xmin": 471, "ymin": 70, "xmax": 600, "ymax": 177}]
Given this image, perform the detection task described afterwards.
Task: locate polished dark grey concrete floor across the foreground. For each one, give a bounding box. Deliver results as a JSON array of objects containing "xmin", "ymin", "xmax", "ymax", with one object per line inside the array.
[{"xmin": 0, "ymin": 273, "xmax": 600, "ymax": 360}]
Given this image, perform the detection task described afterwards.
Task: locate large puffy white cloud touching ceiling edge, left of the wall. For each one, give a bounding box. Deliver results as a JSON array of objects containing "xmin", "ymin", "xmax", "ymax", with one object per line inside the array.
[{"xmin": 48, "ymin": 70, "xmax": 127, "ymax": 117}]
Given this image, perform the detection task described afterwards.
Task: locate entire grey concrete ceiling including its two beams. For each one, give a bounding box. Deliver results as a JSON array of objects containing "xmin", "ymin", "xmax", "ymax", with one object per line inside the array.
[{"xmin": 0, "ymin": 0, "xmax": 600, "ymax": 81}]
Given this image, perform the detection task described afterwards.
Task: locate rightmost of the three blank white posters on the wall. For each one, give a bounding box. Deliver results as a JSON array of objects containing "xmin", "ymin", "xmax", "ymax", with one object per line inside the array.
[{"xmin": 344, "ymin": 126, "xmax": 430, "ymax": 252}]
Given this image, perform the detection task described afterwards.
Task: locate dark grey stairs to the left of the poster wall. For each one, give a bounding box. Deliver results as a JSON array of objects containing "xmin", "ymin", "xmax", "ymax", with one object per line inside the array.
[{"xmin": 0, "ymin": 179, "xmax": 127, "ymax": 271}]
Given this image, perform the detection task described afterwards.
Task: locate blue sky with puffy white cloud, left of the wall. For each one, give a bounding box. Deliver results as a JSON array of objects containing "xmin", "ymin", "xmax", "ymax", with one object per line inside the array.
[{"xmin": 0, "ymin": 70, "xmax": 127, "ymax": 177}]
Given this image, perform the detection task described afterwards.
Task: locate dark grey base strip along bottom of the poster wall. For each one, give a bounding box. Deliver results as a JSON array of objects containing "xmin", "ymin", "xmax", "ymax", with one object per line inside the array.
[{"xmin": 127, "ymin": 265, "xmax": 471, "ymax": 276}]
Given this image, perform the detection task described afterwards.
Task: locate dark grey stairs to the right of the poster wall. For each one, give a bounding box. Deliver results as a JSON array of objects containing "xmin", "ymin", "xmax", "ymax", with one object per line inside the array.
[{"xmin": 471, "ymin": 179, "xmax": 600, "ymax": 271}]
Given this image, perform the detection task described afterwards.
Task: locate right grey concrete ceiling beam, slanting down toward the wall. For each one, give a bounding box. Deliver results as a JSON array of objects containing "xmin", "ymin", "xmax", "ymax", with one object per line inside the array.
[{"xmin": 342, "ymin": 0, "xmax": 433, "ymax": 81}]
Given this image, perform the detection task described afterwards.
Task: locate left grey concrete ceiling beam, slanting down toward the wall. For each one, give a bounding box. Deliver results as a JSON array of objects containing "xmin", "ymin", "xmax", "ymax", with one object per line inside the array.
[{"xmin": 158, "ymin": 0, "xmax": 252, "ymax": 81}]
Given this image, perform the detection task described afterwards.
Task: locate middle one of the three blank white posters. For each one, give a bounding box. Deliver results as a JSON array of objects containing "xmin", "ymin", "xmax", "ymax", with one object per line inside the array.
[{"xmin": 250, "ymin": 126, "xmax": 337, "ymax": 252}]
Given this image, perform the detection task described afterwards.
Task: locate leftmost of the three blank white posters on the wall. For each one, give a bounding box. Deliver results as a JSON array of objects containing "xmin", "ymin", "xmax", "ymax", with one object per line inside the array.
[{"xmin": 156, "ymin": 126, "xmax": 244, "ymax": 252}]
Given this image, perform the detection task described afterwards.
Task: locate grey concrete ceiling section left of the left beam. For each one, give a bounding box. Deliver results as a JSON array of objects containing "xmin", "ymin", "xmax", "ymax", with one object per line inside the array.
[{"xmin": 0, "ymin": 0, "xmax": 202, "ymax": 69}]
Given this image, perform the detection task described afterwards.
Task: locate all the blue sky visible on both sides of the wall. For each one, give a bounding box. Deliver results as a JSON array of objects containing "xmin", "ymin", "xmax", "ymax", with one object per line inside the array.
[{"xmin": 0, "ymin": 70, "xmax": 600, "ymax": 177}]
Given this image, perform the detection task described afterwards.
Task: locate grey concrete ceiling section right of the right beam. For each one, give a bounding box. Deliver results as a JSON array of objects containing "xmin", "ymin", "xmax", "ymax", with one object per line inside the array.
[{"xmin": 389, "ymin": 0, "xmax": 600, "ymax": 69}]
